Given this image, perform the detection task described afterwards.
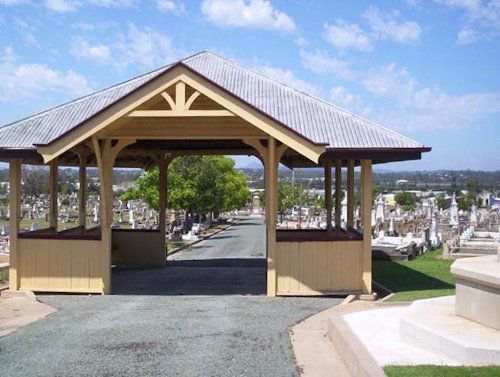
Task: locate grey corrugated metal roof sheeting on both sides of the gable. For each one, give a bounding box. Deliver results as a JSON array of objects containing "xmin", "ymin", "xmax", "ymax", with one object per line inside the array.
[{"xmin": 0, "ymin": 52, "xmax": 424, "ymax": 149}]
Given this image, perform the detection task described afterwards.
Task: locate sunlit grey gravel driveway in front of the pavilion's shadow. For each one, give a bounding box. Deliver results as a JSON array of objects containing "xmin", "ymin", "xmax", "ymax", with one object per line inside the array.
[{"xmin": 0, "ymin": 295, "xmax": 340, "ymax": 377}]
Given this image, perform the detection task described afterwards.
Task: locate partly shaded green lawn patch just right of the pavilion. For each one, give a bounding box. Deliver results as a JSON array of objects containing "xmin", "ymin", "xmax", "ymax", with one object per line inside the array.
[{"xmin": 373, "ymin": 249, "xmax": 455, "ymax": 301}]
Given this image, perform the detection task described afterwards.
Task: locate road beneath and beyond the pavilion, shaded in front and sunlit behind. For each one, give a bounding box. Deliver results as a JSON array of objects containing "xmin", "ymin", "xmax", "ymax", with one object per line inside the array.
[{"xmin": 112, "ymin": 218, "xmax": 266, "ymax": 295}]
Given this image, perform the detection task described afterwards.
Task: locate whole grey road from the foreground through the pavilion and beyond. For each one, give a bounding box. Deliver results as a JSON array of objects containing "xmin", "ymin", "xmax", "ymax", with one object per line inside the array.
[{"xmin": 0, "ymin": 217, "xmax": 340, "ymax": 377}]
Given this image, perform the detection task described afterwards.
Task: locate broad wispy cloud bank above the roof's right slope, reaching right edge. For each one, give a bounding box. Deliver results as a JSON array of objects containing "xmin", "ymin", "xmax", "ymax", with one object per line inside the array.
[{"xmin": 300, "ymin": 42, "xmax": 500, "ymax": 130}]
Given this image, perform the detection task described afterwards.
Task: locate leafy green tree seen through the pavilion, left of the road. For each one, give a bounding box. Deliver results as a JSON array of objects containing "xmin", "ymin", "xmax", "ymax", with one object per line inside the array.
[{"xmin": 120, "ymin": 156, "xmax": 250, "ymax": 215}]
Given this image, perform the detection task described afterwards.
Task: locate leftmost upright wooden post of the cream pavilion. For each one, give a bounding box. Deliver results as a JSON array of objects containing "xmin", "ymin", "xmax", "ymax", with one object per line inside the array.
[{"xmin": 9, "ymin": 159, "xmax": 21, "ymax": 291}]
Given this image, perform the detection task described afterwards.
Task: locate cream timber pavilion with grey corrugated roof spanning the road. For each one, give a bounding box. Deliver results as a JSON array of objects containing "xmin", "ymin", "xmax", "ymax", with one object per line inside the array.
[{"xmin": 0, "ymin": 52, "xmax": 430, "ymax": 296}]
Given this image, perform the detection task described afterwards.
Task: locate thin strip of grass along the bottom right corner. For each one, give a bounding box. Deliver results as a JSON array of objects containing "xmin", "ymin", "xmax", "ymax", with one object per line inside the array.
[{"xmin": 384, "ymin": 365, "xmax": 500, "ymax": 377}]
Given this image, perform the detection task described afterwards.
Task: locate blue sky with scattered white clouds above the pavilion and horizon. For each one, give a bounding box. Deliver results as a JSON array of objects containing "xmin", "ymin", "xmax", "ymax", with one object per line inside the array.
[{"xmin": 0, "ymin": 0, "xmax": 500, "ymax": 170}]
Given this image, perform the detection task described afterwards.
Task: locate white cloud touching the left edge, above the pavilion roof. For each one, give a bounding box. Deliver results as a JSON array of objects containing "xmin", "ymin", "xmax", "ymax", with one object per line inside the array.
[{"xmin": 0, "ymin": 47, "xmax": 91, "ymax": 101}]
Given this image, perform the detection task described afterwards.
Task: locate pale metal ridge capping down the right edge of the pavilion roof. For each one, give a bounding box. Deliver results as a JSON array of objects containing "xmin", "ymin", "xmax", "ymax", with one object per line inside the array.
[{"xmin": 187, "ymin": 51, "xmax": 424, "ymax": 146}]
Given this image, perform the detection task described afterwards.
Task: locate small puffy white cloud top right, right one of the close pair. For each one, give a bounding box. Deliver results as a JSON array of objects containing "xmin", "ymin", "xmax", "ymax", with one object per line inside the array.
[{"xmin": 363, "ymin": 7, "xmax": 422, "ymax": 43}]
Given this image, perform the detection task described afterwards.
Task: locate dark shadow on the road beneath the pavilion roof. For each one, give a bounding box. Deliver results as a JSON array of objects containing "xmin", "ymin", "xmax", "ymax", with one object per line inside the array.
[{"xmin": 112, "ymin": 258, "xmax": 266, "ymax": 296}]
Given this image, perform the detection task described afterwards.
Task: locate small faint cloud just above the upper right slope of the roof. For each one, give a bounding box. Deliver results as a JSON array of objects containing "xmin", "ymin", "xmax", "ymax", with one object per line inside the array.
[{"xmin": 300, "ymin": 50, "xmax": 354, "ymax": 80}]
